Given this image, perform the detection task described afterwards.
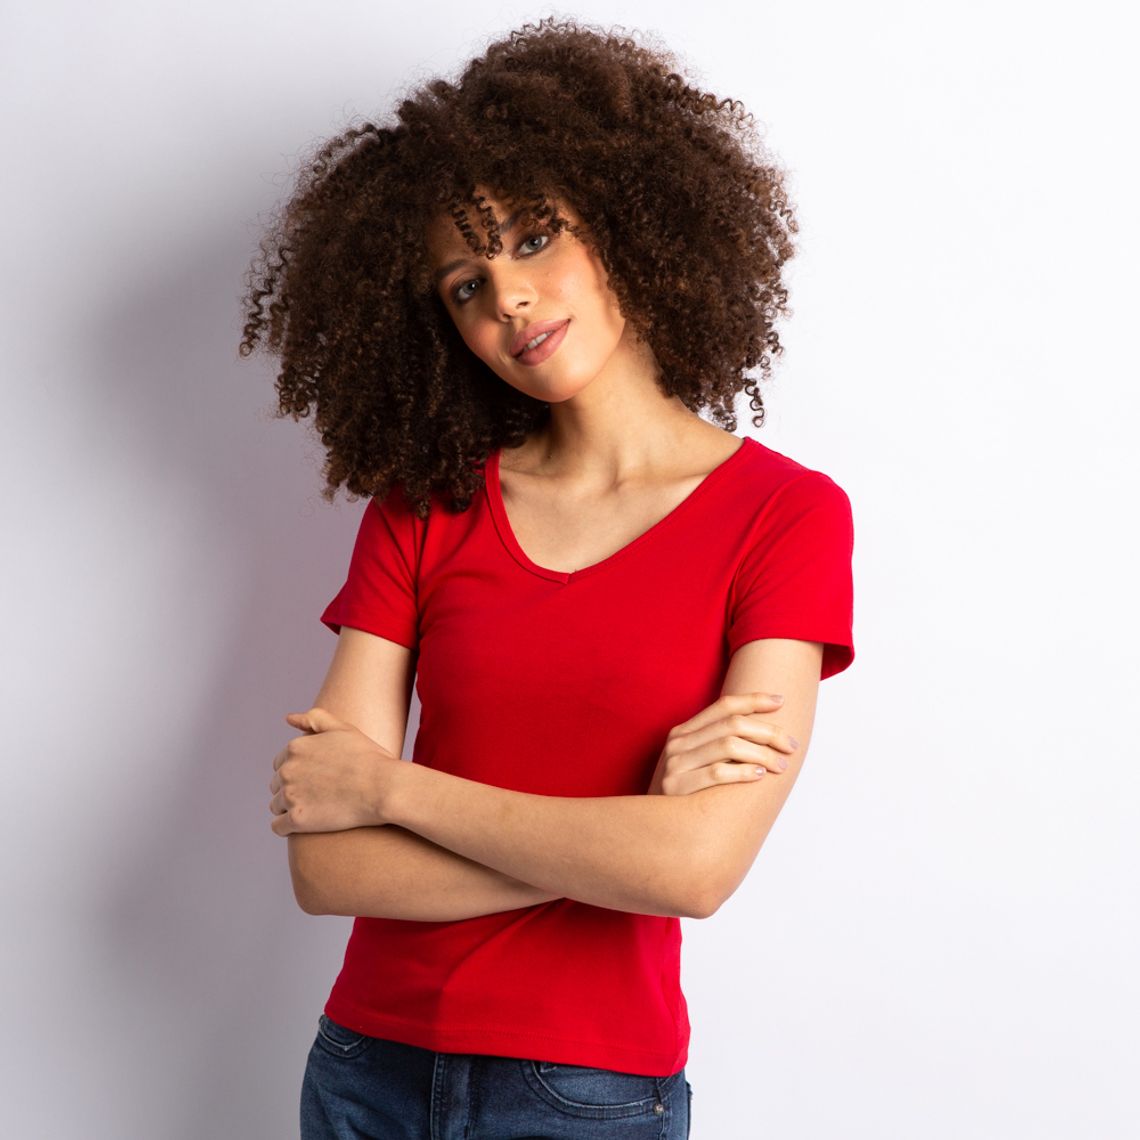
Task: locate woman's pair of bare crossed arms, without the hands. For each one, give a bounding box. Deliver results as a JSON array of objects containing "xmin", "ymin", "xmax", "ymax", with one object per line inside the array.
[{"xmin": 275, "ymin": 627, "xmax": 822, "ymax": 921}]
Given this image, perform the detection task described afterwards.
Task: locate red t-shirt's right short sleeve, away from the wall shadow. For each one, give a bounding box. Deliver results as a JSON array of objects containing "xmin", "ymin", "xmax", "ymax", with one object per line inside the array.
[{"xmin": 726, "ymin": 471, "xmax": 855, "ymax": 679}]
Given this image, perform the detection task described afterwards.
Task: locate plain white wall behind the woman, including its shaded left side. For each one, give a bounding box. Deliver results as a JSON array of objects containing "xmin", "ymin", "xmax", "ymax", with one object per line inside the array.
[{"xmin": 0, "ymin": 0, "xmax": 1140, "ymax": 1140}]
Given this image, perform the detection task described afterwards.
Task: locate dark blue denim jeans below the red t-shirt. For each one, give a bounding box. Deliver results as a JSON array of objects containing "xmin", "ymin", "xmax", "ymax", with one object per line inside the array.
[{"xmin": 301, "ymin": 1013, "xmax": 692, "ymax": 1140}]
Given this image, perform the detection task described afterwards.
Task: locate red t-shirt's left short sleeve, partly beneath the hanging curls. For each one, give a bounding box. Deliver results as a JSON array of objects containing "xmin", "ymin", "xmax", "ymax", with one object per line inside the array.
[{"xmin": 320, "ymin": 486, "xmax": 418, "ymax": 649}]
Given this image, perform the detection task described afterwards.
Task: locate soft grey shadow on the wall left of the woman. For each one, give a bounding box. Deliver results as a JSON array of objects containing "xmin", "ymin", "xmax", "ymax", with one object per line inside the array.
[{"xmin": 87, "ymin": 220, "xmax": 417, "ymax": 1140}]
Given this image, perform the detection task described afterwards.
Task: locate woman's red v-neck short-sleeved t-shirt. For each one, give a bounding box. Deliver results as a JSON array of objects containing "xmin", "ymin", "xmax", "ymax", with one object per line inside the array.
[{"xmin": 321, "ymin": 437, "xmax": 855, "ymax": 1076}]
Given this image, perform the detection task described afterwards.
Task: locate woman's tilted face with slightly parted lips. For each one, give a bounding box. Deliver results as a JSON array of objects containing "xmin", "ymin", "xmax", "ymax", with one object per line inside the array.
[{"xmin": 428, "ymin": 196, "xmax": 630, "ymax": 402}]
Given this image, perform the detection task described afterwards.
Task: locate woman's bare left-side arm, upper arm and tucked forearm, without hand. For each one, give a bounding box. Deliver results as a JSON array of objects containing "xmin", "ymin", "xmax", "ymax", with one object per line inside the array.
[{"xmin": 286, "ymin": 626, "xmax": 561, "ymax": 922}]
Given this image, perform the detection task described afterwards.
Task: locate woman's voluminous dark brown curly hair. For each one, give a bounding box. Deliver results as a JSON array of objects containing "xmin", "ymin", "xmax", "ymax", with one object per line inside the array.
[{"xmin": 238, "ymin": 17, "xmax": 798, "ymax": 518}]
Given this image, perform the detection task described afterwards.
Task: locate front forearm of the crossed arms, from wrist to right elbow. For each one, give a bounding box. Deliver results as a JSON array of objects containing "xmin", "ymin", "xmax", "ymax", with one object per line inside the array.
[{"xmin": 389, "ymin": 765, "xmax": 719, "ymax": 918}]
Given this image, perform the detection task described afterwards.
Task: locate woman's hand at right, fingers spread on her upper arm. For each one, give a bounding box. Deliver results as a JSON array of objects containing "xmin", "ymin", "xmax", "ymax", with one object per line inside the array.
[{"xmin": 649, "ymin": 693, "xmax": 799, "ymax": 796}]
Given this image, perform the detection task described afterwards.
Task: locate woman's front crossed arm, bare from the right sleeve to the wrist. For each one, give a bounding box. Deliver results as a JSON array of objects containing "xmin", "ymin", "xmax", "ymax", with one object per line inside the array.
[{"xmin": 278, "ymin": 638, "xmax": 823, "ymax": 918}]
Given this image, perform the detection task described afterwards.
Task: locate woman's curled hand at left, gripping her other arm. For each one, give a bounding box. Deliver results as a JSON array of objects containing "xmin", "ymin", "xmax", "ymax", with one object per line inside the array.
[{"xmin": 269, "ymin": 707, "xmax": 404, "ymax": 836}]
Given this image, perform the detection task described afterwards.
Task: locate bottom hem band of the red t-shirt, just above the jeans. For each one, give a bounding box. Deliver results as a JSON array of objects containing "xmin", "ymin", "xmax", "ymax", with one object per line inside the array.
[{"xmin": 325, "ymin": 998, "xmax": 689, "ymax": 1076}]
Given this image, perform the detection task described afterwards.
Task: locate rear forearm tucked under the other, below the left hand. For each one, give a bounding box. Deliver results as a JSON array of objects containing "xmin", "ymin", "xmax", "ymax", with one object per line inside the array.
[{"xmin": 287, "ymin": 827, "xmax": 562, "ymax": 922}]
